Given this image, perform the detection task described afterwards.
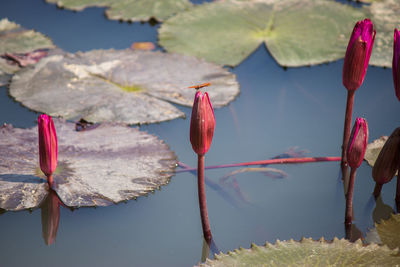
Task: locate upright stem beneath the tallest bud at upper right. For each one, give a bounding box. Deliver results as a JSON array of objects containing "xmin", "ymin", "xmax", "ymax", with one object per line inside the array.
[{"xmin": 341, "ymin": 90, "xmax": 355, "ymax": 180}]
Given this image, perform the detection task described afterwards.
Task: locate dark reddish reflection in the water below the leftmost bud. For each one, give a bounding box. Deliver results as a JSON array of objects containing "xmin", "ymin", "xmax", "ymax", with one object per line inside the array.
[{"xmin": 41, "ymin": 189, "xmax": 61, "ymax": 245}]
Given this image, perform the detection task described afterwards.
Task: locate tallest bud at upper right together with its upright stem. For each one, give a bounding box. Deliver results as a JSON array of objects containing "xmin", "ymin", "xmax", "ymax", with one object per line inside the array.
[{"xmin": 341, "ymin": 19, "xmax": 376, "ymax": 177}]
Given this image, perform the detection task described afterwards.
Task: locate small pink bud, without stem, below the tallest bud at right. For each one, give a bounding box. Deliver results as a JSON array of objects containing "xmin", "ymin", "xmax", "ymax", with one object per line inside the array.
[{"xmin": 347, "ymin": 118, "xmax": 368, "ymax": 168}]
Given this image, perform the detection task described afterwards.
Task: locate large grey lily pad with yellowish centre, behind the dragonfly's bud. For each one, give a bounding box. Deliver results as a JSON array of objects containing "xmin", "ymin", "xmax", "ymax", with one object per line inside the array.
[{"xmin": 10, "ymin": 49, "xmax": 239, "ymax": 124}]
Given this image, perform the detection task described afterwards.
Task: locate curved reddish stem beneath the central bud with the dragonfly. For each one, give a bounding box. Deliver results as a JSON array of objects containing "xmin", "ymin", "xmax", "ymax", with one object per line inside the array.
[{"xmin": 197, "ymin": 154, "xmax": 212, "ymax": 245}]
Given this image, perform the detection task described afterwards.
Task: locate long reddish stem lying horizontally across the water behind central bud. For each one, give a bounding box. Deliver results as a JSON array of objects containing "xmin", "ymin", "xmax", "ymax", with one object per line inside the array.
[{"xmin": 176, "ymin": 157, "xmax": 341, "ymax": 173}]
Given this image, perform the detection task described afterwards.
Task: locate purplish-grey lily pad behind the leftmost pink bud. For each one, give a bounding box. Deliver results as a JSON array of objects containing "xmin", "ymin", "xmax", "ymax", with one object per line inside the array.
[{"xmin": 0, "ymin": 119, "xmax": 176, "ymax": 210}]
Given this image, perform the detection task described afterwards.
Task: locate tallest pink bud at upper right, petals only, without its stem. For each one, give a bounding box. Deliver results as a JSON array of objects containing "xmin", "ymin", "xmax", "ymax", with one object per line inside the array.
[{"xmin": 343, "ymin": 19, "xmax": 376, "ymax": 90}]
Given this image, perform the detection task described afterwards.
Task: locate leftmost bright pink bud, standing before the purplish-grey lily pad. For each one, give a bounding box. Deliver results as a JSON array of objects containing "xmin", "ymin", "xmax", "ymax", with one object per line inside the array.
[{"xmin": 38, "ymin": 114, "xmax": 57, "ymax": 176}]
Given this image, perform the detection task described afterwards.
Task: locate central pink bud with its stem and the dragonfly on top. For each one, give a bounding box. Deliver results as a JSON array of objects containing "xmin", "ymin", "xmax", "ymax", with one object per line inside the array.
[{"xmin": 190, "ymin": 84, "xmax": 215, "ymax": 244}]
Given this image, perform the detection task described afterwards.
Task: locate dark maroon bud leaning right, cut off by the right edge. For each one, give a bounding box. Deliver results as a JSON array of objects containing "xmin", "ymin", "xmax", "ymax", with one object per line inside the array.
[{"xmin": 372, "ymin": 127, "xmax": 400, "ymax": 184}]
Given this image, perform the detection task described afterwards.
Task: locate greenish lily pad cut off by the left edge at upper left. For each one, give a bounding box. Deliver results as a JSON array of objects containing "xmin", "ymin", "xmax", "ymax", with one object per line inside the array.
[{"xmin": 0, "ymin": 18, "xmax": 54, "ymax": 77}]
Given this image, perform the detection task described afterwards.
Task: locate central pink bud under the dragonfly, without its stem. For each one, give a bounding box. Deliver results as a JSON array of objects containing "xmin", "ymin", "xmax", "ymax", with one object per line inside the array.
[{"xmin": 190, "ymin": 91, "xmax": 215, "ymax": 155}]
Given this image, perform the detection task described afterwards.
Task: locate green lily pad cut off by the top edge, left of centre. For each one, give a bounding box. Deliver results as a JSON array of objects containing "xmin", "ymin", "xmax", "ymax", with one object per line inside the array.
[{"xmin": 46, "ymin": 0, "xmax": 192, "ymax": 21}]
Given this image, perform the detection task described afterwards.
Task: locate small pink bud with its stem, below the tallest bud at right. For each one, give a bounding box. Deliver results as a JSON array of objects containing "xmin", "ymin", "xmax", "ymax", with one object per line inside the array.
[{"xmin": 345, "ymin": 118, "xmax": 368, "ymax": 225}]
